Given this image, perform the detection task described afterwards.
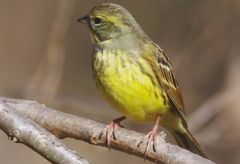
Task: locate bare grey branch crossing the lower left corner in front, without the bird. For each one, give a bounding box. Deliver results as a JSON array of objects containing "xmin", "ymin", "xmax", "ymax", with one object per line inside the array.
[{"xmin": 0, "ymin": 98, "xmax": 90, "ymax": 164}]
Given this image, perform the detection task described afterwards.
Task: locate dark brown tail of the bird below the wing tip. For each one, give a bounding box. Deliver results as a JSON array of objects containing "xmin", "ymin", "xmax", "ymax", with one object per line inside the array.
[{"xmin": 172, "ymin": 128, "xmax": 208, "ymax": 159}]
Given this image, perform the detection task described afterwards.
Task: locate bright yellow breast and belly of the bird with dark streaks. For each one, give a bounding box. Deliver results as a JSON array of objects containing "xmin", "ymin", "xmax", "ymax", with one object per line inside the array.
[{"xmin": 93, "ymin": 50, "xmax": 169, "ymax": 122}]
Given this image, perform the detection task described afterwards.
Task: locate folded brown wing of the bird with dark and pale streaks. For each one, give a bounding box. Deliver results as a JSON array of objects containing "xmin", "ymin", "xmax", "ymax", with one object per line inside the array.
[{"xmin": 153, "ymin": 43, "xmax": 186, "ymax": 121}]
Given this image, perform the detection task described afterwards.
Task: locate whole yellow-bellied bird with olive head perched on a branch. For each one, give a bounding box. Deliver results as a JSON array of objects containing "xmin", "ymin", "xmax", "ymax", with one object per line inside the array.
[{"xmin": 78, "ymin": 3, "xmax": 207, "ymax": 158}]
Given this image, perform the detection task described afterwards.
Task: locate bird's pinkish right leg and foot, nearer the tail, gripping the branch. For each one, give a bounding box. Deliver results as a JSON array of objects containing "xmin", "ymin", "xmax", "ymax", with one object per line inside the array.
[{"xmin": 138, "ymin": 116, "xmax": 161, "ymax": 158}]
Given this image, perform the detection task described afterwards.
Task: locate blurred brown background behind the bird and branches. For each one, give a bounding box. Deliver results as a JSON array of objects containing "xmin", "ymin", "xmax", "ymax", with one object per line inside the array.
[{"xmin": 0, "ymin": 0, "xmax": 240, "ymax": 164}]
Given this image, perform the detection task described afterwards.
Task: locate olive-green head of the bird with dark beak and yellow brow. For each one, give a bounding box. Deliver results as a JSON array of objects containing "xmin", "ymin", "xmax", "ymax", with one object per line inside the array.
[{"xmin": 78, "ymin": 3, "xmax": 143, "ymax": 43}]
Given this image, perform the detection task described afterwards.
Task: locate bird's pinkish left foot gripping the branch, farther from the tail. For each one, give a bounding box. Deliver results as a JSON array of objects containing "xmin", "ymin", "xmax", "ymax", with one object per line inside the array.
[{"xmin": 99, "ymin": 116, "xmax": 126, "ymax": 150}]
